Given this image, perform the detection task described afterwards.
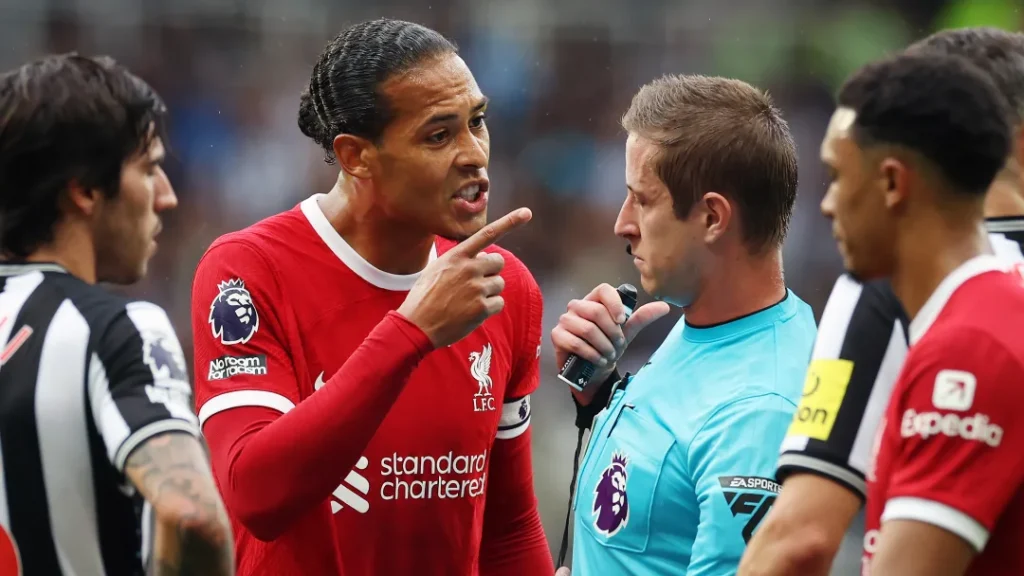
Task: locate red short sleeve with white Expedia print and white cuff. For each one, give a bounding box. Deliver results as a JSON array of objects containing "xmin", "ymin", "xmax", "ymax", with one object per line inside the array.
[{"xmin": 882, "ymin": 329, "xmax": 1024, "ymax": 551}]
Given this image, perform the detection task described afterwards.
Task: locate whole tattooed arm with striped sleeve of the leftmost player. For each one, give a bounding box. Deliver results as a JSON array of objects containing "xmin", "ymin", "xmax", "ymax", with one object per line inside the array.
[{"xmin": 88, "ymin": 299, "xmax": 234, "ymax": 576}]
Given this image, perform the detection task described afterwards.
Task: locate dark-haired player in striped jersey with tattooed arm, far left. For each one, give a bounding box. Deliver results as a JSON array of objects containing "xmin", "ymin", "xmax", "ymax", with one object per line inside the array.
[{"xmin": 0, "ymin": 54, "xmax": 233, "ymax": 576}]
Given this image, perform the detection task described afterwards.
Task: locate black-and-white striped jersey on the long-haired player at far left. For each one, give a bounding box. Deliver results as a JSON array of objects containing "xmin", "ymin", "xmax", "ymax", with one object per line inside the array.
[{"xmin": 0, "ymin": 263, "xmax": 199, "ymax": 576}]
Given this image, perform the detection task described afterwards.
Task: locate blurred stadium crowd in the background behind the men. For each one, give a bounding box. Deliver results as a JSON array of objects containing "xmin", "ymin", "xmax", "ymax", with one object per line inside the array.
[{"xmin": 0, "ymin": 0, "xmax": 1024, "ymax": 572}]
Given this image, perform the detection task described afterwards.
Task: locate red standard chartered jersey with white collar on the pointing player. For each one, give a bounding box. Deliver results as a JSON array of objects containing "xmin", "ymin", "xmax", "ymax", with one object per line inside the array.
[{"xmin": 193, "ymin": 196, "xmax": 542, "ymax": 576}]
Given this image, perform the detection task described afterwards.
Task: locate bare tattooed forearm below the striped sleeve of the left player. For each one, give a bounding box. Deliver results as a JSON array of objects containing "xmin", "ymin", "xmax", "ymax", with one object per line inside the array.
[{"xmin": 125, "ymin": 431, "xmax": 234, "ymax": 576}]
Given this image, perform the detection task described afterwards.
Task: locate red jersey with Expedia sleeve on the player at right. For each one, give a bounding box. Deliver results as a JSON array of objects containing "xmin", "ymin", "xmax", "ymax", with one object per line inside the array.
[{"xmin": 863, "ymin": 255, "xmax": 1024, "ymax": 576}]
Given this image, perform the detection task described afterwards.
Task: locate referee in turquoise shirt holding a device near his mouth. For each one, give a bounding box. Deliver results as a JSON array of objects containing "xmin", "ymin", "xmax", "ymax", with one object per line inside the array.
[{"xmin": 551, "ymin": 76, "xmax": 816, "ymax": 576}]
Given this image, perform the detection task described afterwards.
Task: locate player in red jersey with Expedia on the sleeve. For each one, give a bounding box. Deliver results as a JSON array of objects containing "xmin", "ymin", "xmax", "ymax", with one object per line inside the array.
[{"xmin": 821, "ymin": 54, "xmax": 1024, "ymax": 576}]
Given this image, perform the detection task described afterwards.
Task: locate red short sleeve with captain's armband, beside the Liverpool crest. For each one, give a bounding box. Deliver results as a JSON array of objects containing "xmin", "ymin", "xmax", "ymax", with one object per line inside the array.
[{"xmin": 498, "ymin": 253, "xmax": 544, "ymax": 440}]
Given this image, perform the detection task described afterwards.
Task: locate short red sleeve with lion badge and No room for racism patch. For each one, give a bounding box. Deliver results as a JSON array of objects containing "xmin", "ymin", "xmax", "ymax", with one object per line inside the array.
[{"xmin": 191, "ymin": 241, "xmax": 299, "ymax": 426}]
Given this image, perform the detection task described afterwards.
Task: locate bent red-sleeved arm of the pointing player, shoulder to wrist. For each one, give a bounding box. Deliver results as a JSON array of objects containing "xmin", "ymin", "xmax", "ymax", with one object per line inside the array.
[{"xmin": 193, "ymin": 234, "xmax": 433, "ymax": 541}]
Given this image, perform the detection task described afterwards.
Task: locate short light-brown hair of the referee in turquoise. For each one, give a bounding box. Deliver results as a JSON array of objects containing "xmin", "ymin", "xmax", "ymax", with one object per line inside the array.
[{"xmin": 622, "ymin": 75, "xmax": 798, "ymax": 251}]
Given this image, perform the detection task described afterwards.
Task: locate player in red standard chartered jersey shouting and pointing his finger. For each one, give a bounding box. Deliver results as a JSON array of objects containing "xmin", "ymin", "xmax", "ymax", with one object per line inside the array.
[{"xmin": 193, "ymin": 19, "xmax": 554, "ymax": 576}]
